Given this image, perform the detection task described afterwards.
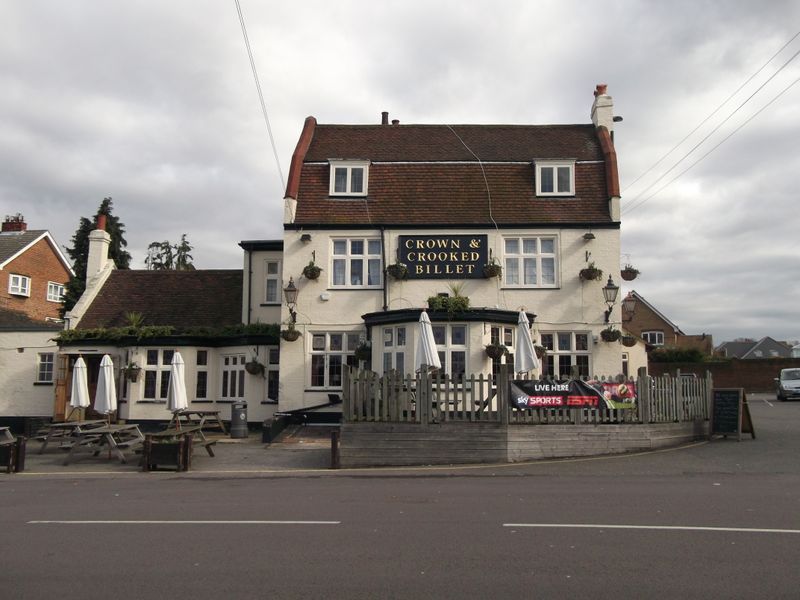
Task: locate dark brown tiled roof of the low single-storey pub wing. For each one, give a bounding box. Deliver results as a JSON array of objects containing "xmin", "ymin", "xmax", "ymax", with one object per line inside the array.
[{"xmin": 78, "ymin": 270, "xmax": 242, "ymax": 329}]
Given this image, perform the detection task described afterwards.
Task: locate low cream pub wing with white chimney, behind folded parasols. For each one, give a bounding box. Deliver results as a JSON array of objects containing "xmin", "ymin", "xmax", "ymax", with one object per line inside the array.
[{"xmin": 55, "ymin": 220, "xmax": 282, "ymax": 422}]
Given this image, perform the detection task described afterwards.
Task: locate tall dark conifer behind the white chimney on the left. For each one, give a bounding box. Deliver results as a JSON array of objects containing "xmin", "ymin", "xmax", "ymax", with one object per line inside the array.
[{"xmin": 61, "ymin": 197, "xmax": 131, "ymax": 315}]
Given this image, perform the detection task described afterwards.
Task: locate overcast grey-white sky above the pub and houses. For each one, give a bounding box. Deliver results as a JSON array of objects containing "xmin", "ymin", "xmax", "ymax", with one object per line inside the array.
[{"xmin": 0, "ymin": 0, "xmax": 800, "ymax": 344}]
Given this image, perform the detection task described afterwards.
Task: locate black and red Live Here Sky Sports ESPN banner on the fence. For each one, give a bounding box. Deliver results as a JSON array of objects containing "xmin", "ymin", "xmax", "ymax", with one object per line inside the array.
[{"xmin": 509, "ymin": 379, "xmax": 636, "ymax": 408}]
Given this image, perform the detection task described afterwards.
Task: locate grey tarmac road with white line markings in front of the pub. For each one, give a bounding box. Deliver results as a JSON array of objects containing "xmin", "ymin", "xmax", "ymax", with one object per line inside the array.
[{"xmin": 0, "ymin": 397, "xmax": 800, "ymax": 599}]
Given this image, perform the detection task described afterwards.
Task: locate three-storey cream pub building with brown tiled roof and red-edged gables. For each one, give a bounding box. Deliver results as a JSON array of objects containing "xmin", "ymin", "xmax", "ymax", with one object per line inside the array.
[{"xmin": 280, "ymin": 85, "xmax": 644, "ymax": 411}]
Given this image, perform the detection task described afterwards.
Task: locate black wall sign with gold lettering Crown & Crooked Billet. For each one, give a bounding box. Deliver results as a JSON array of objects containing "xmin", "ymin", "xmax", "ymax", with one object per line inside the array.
[{"xmin": 397, "ymin": 234, "xmax": 489, "ymax": 279}]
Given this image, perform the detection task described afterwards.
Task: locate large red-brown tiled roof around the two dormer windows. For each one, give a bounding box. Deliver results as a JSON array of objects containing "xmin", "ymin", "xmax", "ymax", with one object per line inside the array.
[{"xmin": 295, "ymin": 125, "xmax": 611, "ymax": 226}]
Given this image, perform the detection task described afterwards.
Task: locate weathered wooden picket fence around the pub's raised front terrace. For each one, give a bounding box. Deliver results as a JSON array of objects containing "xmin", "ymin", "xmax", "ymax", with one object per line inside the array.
[{"xmin": 342, "ymin": 365, "xmax": 712, "ymax": 425}]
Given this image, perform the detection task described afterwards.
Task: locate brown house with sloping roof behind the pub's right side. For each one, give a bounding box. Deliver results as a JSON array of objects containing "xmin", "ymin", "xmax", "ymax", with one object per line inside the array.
[{"xmin": 622, "ymin": 290, "xmax": 714, "ymax": 356}]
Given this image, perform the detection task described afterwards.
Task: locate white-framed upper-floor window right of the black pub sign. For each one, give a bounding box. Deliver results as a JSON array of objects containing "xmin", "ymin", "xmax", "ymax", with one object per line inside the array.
[{"xmin": 503, "ymin": 236, "xmax": 557, "ymax": 287}]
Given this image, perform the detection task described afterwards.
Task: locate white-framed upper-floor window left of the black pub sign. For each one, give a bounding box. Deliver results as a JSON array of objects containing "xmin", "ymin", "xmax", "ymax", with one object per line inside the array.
[{"xmin": 331, "ymin": 238, "xmax": 382, "ymax": 288}]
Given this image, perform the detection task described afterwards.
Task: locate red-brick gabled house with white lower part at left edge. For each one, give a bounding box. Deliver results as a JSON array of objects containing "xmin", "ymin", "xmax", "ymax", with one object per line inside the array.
[{"xmin": 0, "ymin": 214, "xmax": 72, "ymax": 422}]
